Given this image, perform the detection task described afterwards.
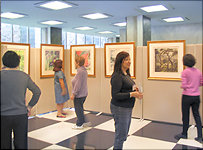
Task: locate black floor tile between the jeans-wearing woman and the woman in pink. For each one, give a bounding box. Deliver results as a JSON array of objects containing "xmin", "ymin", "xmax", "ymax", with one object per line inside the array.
[{"xmin": 133, "ymin": 122, "xmax": 182, "ymax": 143}]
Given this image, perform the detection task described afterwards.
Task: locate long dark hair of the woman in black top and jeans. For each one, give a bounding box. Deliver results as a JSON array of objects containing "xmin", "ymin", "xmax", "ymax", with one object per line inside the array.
[{"xmin": 114, "ymin": 51, "xmax": 130, "ymax": 76}]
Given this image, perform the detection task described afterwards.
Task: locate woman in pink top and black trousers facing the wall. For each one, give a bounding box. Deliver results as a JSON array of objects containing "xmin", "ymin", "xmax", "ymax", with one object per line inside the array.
[{"xmin": 175, "ymin": 54, "xmax": 203, "ymax": 143}]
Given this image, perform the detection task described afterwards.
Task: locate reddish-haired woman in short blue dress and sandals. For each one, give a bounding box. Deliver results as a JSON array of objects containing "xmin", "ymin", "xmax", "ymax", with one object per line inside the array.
[{"xmin": 53, "ymin": 59, "xmax": 69, "ymax": 118}]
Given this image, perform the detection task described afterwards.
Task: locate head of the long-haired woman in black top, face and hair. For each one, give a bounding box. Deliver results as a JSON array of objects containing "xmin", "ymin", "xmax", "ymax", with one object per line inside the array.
[{"xmin": 114, "ymin": 51, "xmax": 131, "ymax": 75}]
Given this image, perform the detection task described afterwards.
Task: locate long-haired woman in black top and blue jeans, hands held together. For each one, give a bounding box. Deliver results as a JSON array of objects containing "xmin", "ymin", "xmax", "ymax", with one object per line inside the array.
[{"xmin": 110, "ymin": 52, "xmax": 143, "ymax": 149}]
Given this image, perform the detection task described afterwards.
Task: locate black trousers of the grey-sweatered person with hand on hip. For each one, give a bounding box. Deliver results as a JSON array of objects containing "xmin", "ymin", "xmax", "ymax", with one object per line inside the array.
[{"xmin": 1, "ymin": 114, "xmax": 28, "ymax": 149}]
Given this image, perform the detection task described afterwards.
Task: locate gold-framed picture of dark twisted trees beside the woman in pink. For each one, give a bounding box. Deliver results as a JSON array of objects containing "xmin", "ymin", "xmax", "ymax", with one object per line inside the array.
[{"xmin": 147, "ymin": 40, "xmax": 185, "ymax": 80}]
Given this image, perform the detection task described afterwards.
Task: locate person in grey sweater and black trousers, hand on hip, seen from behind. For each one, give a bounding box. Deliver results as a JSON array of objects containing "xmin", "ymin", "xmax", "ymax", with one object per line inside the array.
[{"xmin": 0, "ymin": 51, "xmax": 41, "ymax": 149}]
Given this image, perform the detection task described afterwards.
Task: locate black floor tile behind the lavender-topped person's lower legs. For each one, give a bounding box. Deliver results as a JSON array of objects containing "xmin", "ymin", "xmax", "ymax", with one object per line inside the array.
[{"xmin": 65, "ymin": 113, "xmax": 112, "ymax": 127}]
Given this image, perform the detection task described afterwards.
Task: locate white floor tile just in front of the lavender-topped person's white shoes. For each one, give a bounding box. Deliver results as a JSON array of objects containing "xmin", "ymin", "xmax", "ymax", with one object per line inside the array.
[{"xmin": 28, "ymin": 122, "xmax": 91, "ymax": 144}]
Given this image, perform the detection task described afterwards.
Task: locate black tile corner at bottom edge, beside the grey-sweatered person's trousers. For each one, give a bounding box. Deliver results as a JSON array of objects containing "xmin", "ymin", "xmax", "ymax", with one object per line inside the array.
[{"xmin": 28, "ymin": 137, "xmax": 52, "ymax": 149}]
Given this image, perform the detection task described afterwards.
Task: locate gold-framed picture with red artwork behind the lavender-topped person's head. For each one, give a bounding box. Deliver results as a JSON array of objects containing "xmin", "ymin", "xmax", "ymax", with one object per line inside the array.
[{"xmin": 70, "ymin": 44, "xmax": 96, "ymax": 77}]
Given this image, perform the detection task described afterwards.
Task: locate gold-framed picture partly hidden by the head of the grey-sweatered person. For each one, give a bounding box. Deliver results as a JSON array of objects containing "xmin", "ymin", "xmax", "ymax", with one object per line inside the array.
[{"xmin": 1, "ymin": 42, "xmax": 30, "ymax": 74}]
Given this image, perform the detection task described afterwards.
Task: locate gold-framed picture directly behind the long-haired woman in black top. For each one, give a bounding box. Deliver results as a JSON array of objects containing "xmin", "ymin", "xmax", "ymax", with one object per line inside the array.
[{"xmin": 104, "ymin": 42, "xmax": 136, "ymax": 78}]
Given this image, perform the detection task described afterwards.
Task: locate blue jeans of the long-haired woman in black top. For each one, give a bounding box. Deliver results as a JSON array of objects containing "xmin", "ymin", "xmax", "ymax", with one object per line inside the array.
[{"xmin": 111, "ymin": 104, "xmax": 132, "ymax": 149}]
